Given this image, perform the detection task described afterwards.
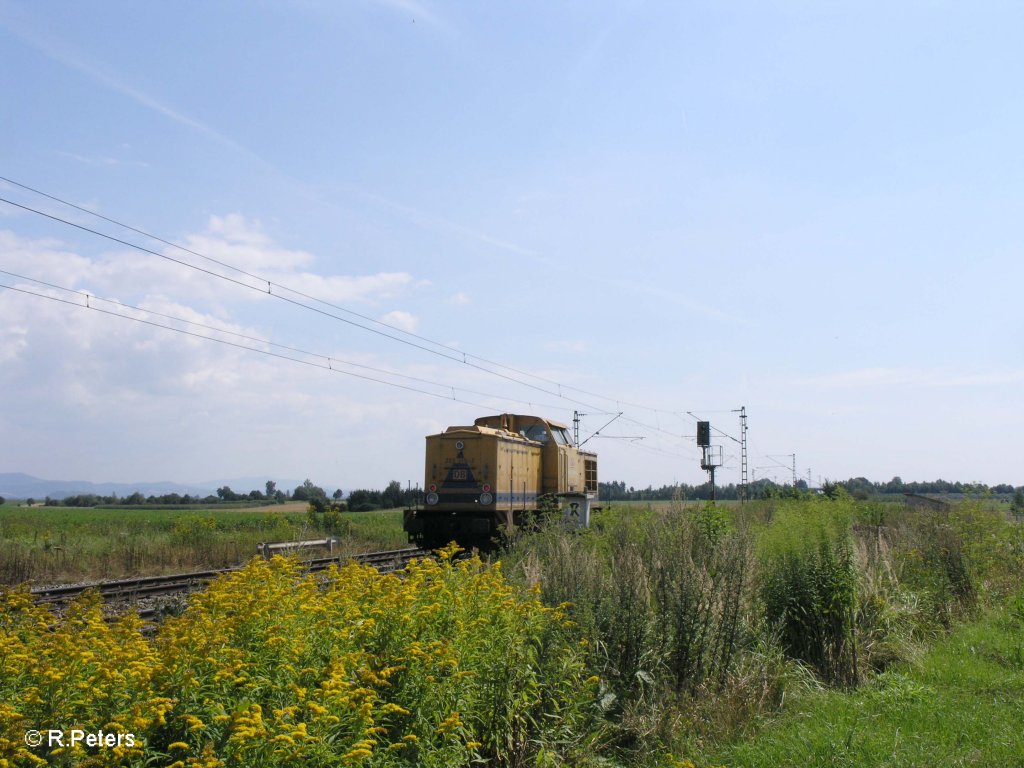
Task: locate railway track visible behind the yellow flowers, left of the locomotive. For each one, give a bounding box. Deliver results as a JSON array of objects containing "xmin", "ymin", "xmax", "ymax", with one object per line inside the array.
[{"xmin": 32, "ymin": 548, "xmax": 430, "ymax": 617}]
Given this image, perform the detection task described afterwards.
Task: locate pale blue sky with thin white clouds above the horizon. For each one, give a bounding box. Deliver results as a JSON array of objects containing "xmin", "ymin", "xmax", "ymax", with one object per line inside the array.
[{"xmin": 0, "ymin": 0, "xmax": 1024, "ymax": 489}]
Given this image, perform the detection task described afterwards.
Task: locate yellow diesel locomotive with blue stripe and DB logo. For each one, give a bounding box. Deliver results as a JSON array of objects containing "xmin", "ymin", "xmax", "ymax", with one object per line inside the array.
[{"xmin": 402, "ymin": 414, "xmax": 597, "ymax": 548}]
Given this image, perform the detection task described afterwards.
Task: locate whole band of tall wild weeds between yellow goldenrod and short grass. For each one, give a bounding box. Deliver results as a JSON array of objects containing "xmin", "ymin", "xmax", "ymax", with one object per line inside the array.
[{"xmin": 502, "ymin": 496, "xmax": 1024, "ymax": 760}]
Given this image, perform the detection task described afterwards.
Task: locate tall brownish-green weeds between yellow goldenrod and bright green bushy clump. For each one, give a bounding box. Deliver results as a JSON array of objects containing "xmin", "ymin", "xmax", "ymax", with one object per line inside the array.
[{"xmin": 503, "ymin": 505, "xmax": 777, "ymax": 755}]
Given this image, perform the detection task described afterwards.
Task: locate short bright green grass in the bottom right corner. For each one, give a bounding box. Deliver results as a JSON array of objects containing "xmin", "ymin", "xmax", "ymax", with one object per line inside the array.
[{"xmin": 701, "ymin": 608, "xmax": 1024, "ymax": 768}]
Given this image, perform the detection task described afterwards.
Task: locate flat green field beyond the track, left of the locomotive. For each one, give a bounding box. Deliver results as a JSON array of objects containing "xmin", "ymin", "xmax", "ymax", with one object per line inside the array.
[{"xmin": 0, "ymin": 502, "xmax": 406, "ymax": 584}]
